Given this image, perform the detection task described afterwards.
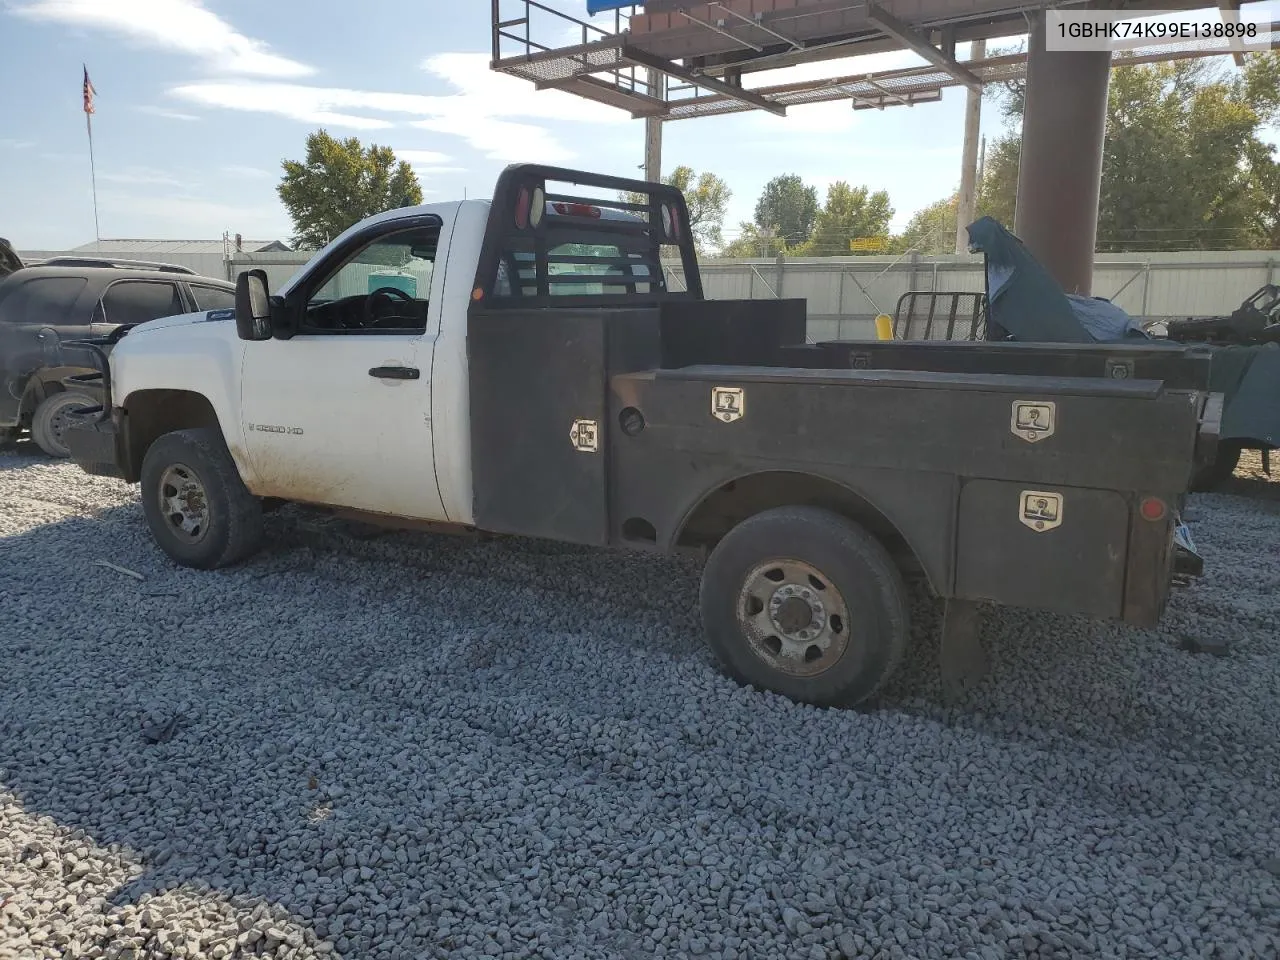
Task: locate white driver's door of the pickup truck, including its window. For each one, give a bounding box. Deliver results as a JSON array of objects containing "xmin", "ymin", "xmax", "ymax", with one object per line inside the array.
[{"xmin": 241, "ymin": 216, "xmax": 445, "ymax": 520}]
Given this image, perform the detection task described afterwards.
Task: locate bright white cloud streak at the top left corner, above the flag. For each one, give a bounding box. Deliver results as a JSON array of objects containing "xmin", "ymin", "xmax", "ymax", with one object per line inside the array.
[{"xmin": 12, "ymin": 0, "xmax": 315, "ymax": 77}]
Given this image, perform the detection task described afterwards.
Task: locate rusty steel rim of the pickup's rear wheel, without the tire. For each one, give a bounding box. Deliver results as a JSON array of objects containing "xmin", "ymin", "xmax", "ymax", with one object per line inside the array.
[{"xmin": 735, "ymin": 559, "xmax": 849, "ymax": 677}]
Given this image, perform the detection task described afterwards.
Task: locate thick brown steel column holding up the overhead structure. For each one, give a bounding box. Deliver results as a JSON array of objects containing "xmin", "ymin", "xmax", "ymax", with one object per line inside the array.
[{"xmin": 1014, "ymin": 12, "xmax": 1111, "ymax": 294}]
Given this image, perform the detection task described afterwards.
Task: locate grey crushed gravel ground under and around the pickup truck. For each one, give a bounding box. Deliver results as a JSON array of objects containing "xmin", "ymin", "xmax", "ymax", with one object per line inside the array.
[{"xmin": 0, "ymin": 447, "xmax": 1280, "ymax": 960}]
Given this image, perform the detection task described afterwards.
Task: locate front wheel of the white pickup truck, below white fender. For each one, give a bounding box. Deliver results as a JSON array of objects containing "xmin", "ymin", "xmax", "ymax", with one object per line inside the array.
[{"xmin": 141, "ymin": 428, "xmax": 262, "ymax": 570}]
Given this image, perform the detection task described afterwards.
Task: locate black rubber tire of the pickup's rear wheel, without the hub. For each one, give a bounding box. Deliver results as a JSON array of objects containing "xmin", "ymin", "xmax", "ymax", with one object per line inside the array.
[{"xmin": 699, "ymin": 507, "xmax": 910, "ymax": 707}]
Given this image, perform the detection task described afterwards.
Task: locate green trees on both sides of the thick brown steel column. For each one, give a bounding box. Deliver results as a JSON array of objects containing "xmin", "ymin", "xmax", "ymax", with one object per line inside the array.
[{"xmin": 979, "ymin": 51, "xmax": 1280, "ymax": 251}]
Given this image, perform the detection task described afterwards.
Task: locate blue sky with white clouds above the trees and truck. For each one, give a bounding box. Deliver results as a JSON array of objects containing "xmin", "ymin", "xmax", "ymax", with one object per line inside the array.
[{"xmin": 0, "ymin": 0, "xmax": 1029, "ymax": 250}]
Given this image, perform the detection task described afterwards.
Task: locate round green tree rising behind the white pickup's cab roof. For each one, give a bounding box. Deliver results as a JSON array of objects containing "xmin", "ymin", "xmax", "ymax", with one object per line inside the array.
[{"xmin": 276, "ymin": 129, "xmax": 422, "ymax": 248}]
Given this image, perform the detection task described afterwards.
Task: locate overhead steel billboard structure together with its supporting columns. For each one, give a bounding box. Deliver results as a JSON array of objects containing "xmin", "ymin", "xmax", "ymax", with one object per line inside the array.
[{"xmin": 490, "ymin": 0, "xmax": 1280, "ymax": 294}]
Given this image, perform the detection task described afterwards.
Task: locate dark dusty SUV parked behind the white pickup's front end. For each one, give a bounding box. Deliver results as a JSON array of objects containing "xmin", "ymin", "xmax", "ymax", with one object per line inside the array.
[{"xmin": 0, "ymin": 239, "xmax": 236, "ymax": 457}]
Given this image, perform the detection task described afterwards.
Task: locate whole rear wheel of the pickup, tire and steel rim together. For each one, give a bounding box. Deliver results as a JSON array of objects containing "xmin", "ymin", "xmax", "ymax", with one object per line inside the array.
[{"xmin": 700, "ymin": 507, "xmax": 910, "ymax": 707}]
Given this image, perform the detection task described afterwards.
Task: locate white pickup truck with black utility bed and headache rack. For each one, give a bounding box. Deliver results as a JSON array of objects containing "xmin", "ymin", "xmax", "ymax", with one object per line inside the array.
[{"xmin": 67, "ymin": 165, "xmax": 1215, "ymax": 704}]
